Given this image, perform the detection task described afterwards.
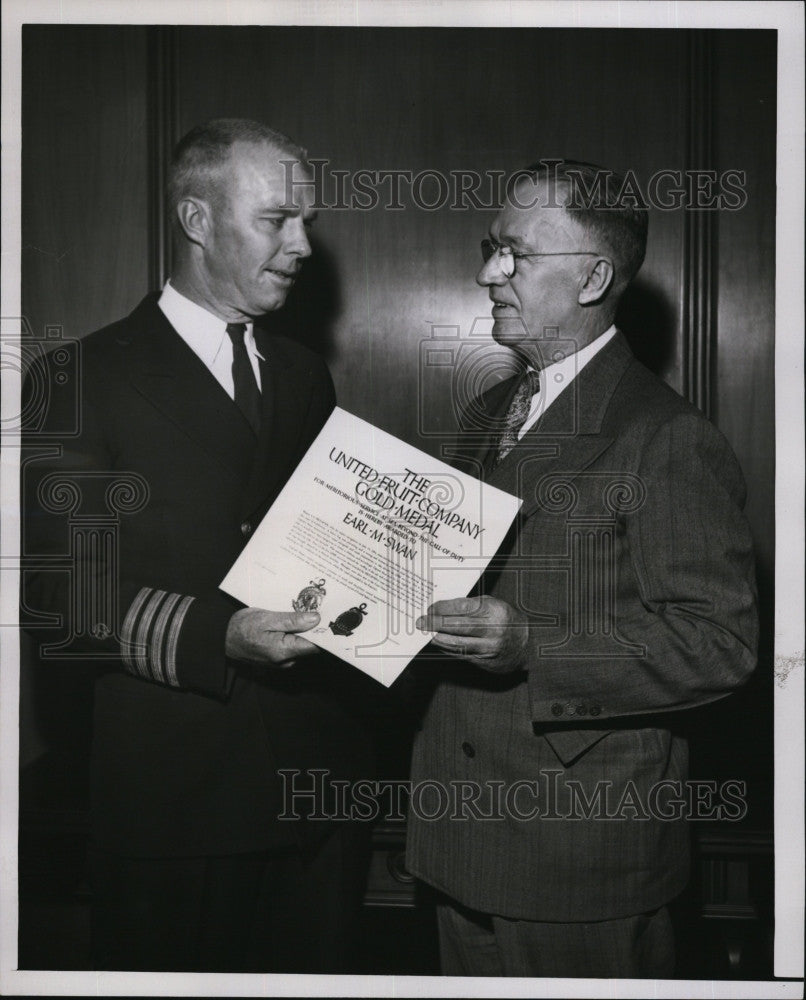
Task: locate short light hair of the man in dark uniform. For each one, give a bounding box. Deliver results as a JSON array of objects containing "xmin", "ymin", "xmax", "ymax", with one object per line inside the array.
[{"xmin": 167, "ymin": 118, "xmax": 308, "ymax": 222}]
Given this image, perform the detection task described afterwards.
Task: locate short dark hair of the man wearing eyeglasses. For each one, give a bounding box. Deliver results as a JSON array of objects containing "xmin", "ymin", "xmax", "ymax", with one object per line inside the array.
[{"xmin": 512, "ymin": 159, "xmax": 649, "ymax": 285}]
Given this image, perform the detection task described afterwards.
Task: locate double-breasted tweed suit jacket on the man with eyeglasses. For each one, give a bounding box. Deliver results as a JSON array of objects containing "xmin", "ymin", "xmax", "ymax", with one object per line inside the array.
[{"xmin": 407, "ymin": 334, "xmax": 757, "ymax": 921}]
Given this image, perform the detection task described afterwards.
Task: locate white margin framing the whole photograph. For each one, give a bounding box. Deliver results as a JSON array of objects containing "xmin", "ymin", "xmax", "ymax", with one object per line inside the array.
[{"xmin": 0, "ymin": 0, "xmax": 806, "ymax": 1000}]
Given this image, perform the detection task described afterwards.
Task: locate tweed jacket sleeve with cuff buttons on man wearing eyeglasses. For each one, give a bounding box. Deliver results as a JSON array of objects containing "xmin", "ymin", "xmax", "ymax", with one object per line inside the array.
[{"xmin": 529, "ymin": 414, "xmax": 758, "ymax": 726}]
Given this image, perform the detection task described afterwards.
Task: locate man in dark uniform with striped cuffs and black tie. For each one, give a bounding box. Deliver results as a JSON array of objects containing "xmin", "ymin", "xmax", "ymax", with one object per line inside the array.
[{"xmin": 24, "ymin": 119, "xmax": 370, "ymax": 972}]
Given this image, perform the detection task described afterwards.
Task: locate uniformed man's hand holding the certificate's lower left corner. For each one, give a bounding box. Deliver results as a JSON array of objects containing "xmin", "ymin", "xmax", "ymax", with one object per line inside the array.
[{"xmin": 226, "ymin": 608, "xmax": 319, "ymax": 667}]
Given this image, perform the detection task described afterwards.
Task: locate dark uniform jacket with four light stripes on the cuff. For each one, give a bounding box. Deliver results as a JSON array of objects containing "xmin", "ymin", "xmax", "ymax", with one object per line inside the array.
[{"xmin": 23, "ymin": 295, "xmax": 376, "ymax": 857}]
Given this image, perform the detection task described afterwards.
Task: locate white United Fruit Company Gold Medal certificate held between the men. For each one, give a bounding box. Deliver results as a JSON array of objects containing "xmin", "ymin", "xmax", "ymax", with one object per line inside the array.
[{"xmin": 221, "ymin": 407, "xmax": 521, "ymax": 685}]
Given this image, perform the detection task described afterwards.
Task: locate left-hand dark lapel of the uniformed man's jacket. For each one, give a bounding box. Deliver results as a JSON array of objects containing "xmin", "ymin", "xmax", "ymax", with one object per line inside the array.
[{"xmin": 126, "ymin": 295, "xmax": 255, "ymax": 480}]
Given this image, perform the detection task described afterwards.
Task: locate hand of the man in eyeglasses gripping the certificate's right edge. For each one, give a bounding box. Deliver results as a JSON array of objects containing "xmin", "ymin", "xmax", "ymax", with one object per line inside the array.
[{"xmin": 417, "ymin": 596, "xmax": 529, "ymax": 673}]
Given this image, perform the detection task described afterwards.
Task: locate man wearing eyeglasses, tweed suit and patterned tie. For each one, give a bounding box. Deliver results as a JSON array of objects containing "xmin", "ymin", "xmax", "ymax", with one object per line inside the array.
[{"xmin": 407, "ymin": 161, "xmax": 757, "ymax": 978}]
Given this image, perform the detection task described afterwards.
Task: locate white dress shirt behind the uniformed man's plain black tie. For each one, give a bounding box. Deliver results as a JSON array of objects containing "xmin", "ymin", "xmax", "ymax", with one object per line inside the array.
[{"xmin": 158, "ymin": 281, "xmax": 266, "ymax": 399}]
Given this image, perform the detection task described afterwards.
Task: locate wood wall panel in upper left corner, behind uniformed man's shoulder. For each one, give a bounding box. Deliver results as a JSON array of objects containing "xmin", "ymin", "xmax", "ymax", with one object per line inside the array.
[{"xmin": 22, "ymin": 25, "xmax": 148, "ymax": 337}]
